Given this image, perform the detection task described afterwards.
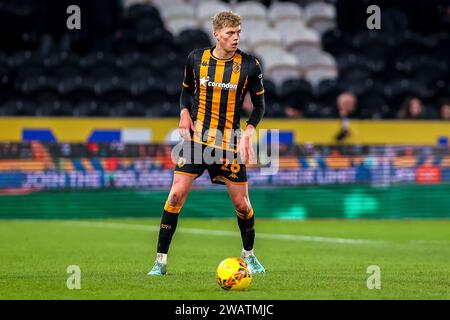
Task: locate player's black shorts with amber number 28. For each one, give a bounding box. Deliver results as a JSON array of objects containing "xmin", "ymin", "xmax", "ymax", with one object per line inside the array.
[{"xmin": 174, "ymin": 141, "xmax": 247, "ymax": 184}]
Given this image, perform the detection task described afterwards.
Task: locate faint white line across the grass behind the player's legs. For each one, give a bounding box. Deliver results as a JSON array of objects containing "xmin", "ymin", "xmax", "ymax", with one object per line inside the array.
[{"xmin": 61, "ymin": 221, "xmax": 374, "ymax": 244}]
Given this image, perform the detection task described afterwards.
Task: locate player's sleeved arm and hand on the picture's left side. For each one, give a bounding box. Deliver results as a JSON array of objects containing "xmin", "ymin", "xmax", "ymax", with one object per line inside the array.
[{"xmin": 178, "ymin": 52, "xmax": 195, "ymax": 140}]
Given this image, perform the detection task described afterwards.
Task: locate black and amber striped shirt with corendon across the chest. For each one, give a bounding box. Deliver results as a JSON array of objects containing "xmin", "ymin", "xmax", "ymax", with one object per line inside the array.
[{"xmin": 181, "ymin": 47, "xmax": 265, "ymax": 150}]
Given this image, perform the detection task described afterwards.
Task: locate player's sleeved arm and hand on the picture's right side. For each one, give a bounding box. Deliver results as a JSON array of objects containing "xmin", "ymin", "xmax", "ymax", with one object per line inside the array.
[{"xmin": 239, "ymin": 59, "xmax": 266, "ymax": 163}]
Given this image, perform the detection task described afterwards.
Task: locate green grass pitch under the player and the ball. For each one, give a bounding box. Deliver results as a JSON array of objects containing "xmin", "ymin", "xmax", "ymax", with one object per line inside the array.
[{"xmin": 0, "ymin": 217, "xmax": 450, "ymax": 300}]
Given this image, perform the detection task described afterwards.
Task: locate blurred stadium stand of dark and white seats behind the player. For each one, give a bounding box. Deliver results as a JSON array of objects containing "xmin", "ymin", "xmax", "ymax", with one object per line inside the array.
[{"xmin": 0, "ymin": 0, "xmax": 450, "ymax": 119}]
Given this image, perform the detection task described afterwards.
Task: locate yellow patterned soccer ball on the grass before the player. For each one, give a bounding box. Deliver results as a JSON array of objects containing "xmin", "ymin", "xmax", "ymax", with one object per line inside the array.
[{"xmin": 216, "ymin": 258, "xmax": 252, "ymax": 290}]
